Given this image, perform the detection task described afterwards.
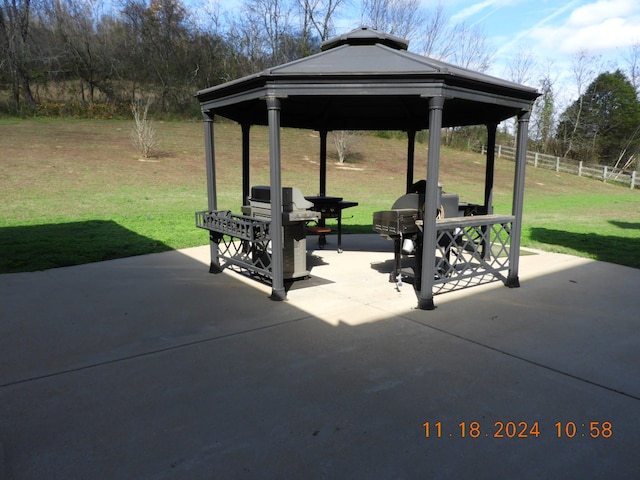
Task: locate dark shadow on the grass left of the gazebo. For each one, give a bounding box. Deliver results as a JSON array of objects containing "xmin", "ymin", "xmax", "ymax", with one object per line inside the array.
[{"xmin": 0, "ymin": 220, "xmax": 172, "ymax": 273}]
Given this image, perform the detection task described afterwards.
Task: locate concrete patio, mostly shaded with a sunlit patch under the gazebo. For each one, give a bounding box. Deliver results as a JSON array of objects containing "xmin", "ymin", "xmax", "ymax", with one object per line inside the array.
[{"xmin": 0, "ymin": 235, "xmax": 640, "ymax": 480}]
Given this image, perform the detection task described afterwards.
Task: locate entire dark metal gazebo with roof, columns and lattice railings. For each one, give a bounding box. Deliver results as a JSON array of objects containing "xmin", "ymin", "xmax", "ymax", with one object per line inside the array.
[{"xmin": 196, "ymin": 27, "xmax": 539, "ymax": 309}]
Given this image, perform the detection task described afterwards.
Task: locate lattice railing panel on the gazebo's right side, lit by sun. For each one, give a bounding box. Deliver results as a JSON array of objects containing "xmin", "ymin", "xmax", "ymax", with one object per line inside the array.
[{"xmin": 433, "ymin": 215, "xmax": 515, "ymax": 294}]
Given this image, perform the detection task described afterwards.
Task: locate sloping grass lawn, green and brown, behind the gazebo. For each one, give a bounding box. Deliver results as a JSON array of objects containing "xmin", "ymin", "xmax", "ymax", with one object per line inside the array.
[{"xmin": 0, "ymin": 119, "xmax": 640, "ymax": 273}]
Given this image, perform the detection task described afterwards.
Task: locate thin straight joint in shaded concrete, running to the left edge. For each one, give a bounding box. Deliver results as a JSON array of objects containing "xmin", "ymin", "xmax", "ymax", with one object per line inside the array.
[{"xmin": 0, "ymin": 315, "xmax": 314, "ymax": 390}]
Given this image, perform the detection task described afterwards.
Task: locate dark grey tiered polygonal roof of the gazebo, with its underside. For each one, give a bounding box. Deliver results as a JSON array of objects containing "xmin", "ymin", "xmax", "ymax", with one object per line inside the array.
[{"xmin": 197, "ymin": 27, "xmax": 538, "ymax": 130}]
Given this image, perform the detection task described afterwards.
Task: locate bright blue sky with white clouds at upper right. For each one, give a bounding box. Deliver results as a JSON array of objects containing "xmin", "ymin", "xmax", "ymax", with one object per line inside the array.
[{"xmin": 440, "ymin": 0, "xmax": 640, "ymax": 83}]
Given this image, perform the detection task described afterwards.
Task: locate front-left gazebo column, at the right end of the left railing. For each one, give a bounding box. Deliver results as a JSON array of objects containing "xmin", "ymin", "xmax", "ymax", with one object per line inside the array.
[{"xmin": 266, "ymin": 96, "xmax": 287, "ymax": 300}]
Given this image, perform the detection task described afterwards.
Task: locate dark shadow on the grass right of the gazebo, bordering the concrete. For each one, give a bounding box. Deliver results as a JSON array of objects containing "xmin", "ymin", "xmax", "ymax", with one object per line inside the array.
[{"xmin": 530, "ymin": 226, "xmax": 640, "ymax": 268}]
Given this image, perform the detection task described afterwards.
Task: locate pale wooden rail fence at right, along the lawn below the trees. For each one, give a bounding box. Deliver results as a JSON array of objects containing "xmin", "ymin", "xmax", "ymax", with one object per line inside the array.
[{"xmin": 482, "ymin": 145, "xmax": 640, "ymax": 189}]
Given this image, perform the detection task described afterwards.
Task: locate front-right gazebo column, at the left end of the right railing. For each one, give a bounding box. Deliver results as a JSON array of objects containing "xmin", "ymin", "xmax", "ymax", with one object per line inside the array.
[{"xmin": 418, "ymin": 97, "xmax": 444, "ymax": 310}]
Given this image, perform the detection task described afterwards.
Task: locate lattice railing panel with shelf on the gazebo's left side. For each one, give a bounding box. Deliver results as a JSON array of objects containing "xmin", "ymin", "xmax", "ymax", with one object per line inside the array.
[{"xmin": 196, "ymin": 210, "xmax": 273, "ymax": 278}]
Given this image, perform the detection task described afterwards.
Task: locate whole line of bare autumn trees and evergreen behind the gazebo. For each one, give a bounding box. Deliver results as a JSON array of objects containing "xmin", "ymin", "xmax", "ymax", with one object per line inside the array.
[{"xmin": 0, "ymin": 0, "xmax": 640, "ymax": 169}]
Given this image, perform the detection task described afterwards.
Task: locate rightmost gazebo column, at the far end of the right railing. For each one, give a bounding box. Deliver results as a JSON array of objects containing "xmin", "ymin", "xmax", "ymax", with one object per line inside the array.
[{"xmin": 505, "ymin": 111, "xmax": 531, "ymax": 288}]
